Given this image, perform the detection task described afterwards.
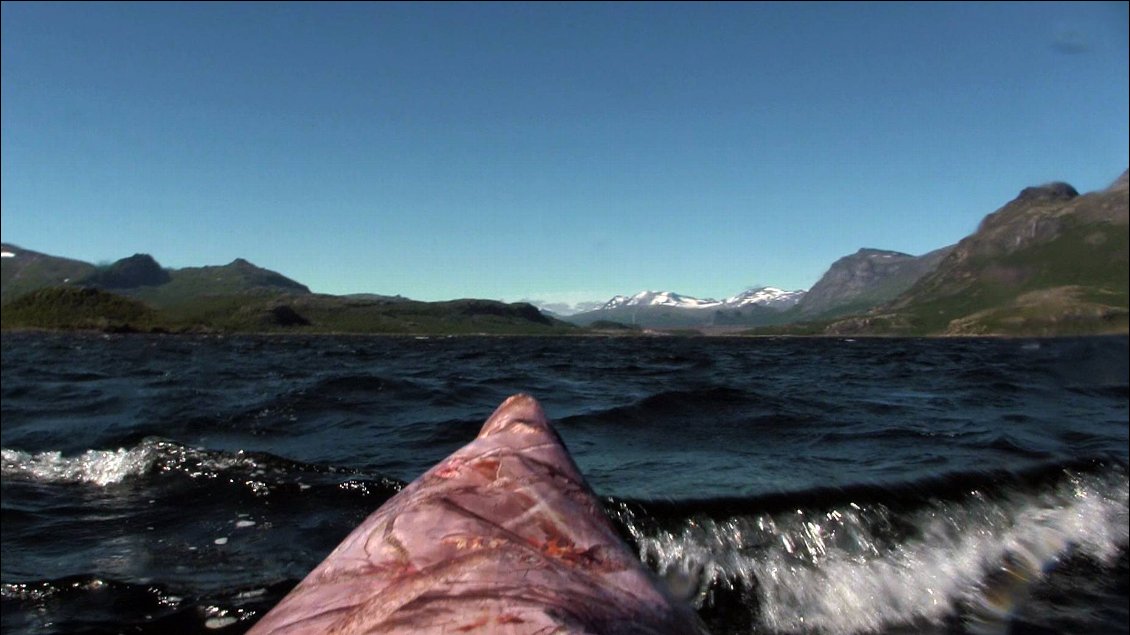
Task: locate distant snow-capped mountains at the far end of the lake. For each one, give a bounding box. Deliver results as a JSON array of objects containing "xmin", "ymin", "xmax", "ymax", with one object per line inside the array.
[{"xmin": 563, "ymin": 287, "xmax": 805, "ymax": 329}]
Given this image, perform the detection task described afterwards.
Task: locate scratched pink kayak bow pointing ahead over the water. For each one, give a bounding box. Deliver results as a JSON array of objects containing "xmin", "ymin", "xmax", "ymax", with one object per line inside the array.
[{"xmin": 251, "ymin": 394, "xmax": 705, "ymax": 634}]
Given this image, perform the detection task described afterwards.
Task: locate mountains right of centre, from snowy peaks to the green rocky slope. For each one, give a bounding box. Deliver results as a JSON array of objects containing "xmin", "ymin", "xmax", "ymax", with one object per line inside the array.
[{"xmin": 553, "ymin": 168, "xmax": 1128, "ymax": 334}]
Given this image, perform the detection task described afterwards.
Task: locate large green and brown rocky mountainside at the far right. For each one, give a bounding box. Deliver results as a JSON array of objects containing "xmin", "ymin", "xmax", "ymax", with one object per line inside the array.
[{"xmin": 827, "ymin": 173, "xmax": 1130, "ymax": 336}]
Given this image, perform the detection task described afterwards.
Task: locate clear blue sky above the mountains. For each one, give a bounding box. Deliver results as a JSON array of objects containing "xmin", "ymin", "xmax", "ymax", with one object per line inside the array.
[{"xmin": 0, "ymin": 2, "xmax": 1130, "ymax": 302}]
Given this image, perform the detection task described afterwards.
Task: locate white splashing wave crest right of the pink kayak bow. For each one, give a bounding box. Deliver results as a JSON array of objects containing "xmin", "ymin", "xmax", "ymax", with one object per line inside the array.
[{"xmin": 614, "ymin": 466, "xmax": 1130, "ymax": 633}]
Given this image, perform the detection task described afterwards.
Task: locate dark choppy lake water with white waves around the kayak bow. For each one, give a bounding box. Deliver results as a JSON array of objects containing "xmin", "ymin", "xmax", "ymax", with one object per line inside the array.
[{"xmin": 0, "ymin": 334, "xmax": 1130, "ymax": 634}]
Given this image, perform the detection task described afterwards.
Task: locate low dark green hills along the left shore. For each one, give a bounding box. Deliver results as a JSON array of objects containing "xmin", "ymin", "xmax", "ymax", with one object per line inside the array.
[{"xmin": 0, "ymin": 244, "xmax": 575, "ymax": 334}]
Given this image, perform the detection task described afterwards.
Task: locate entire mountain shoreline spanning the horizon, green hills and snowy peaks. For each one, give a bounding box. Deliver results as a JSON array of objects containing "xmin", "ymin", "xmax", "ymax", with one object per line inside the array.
[{"xmin": 0, "ymin": 172, "xmax": 1130, "ymax": 336}]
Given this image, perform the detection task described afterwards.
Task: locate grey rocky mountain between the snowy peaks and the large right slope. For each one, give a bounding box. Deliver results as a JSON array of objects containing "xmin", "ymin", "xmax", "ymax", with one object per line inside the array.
[{"xmin": 793, "ymin": 246, "xmax": 953, "ymax": 320}]
